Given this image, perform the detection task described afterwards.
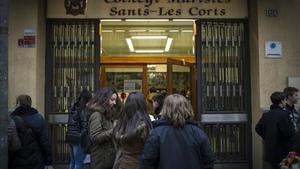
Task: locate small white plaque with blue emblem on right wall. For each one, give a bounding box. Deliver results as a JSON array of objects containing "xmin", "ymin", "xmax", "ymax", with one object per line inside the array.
[{"xmin": 265, "ymin": 41, "xmax": 282, "ymax": 58}]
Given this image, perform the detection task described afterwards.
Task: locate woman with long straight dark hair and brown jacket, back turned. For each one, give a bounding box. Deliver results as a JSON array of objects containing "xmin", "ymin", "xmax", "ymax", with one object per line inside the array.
[{"xmin": 113, "ymin": 92, "xmax": 152, "ymax": 169}]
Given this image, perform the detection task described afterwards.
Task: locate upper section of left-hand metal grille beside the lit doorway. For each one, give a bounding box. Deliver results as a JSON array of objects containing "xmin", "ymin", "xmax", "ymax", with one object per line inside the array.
[{"xmin": 50, "ymin": 20, "xmax": 95, "ymax": 112}]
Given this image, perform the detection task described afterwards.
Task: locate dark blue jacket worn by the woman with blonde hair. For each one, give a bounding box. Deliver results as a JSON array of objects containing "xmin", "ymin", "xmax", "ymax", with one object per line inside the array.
[{"xmin": 140, "ymin": 120, "xmax": 215, "ymax": 169}]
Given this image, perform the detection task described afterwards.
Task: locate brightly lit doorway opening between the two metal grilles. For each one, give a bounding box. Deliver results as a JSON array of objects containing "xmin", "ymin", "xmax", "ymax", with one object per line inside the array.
[{"xmin": 100, "ymin": 20, "xmax": 196, "ymax": 115}]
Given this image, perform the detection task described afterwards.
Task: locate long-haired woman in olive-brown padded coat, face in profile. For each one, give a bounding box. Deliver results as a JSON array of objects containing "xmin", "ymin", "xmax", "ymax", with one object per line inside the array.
[{"xmin": 87, "ymin": 87, "xmax": 118, "ymax": 169}]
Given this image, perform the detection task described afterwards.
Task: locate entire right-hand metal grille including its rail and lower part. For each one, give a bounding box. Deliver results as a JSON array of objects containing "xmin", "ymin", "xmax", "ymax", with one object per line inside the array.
[{"xmin": 198, "ymin": 20, "xmax": 251, "ymax": 163}]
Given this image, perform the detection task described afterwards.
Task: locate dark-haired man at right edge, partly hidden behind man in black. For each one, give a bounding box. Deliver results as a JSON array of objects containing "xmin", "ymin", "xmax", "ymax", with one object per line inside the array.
[{"xmin": 283, "ymin": 87, "xmax": 300, "ymax": 133}]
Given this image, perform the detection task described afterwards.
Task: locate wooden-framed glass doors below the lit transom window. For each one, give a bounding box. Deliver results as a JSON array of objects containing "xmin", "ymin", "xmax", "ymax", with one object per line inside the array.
[{"xmin": 100, "ymin": 59, "xmax": 196, "ymax": 108}]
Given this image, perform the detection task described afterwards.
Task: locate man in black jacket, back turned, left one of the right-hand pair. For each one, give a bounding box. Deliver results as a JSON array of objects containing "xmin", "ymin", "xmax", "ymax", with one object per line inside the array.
[{"xmin": 255, "ymin": 92, "xmax": 295, "ymax": 169}]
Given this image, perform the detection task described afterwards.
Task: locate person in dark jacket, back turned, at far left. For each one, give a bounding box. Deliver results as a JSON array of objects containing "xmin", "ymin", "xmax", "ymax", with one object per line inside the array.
[{"xmin": 10, "ymin": 95, "xmax": 52, "ymax": 169}]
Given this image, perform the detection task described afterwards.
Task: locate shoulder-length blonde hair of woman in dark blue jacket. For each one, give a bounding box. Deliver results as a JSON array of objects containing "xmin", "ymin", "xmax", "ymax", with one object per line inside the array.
[{"xmin": 161, "ymin": 94, "xmax": 194, "ymax": 127}]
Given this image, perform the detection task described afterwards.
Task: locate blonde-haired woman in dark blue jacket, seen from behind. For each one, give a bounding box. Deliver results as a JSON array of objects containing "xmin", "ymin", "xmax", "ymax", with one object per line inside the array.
[{"xmin": 139, "ymin": 94, "xmax": 215, "ymax": 169}]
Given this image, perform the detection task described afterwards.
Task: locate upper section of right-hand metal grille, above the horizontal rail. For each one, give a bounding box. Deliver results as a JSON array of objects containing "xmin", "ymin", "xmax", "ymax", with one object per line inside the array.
[{"xmin": 201, "ymin": 22, "xmax": 245, "ymax": 111}]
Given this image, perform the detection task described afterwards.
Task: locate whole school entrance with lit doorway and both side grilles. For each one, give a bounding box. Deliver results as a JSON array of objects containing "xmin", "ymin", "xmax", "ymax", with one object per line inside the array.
[{"xmin": 46, "ymin": 19, "xmax": 251, "ymax": 169}]
